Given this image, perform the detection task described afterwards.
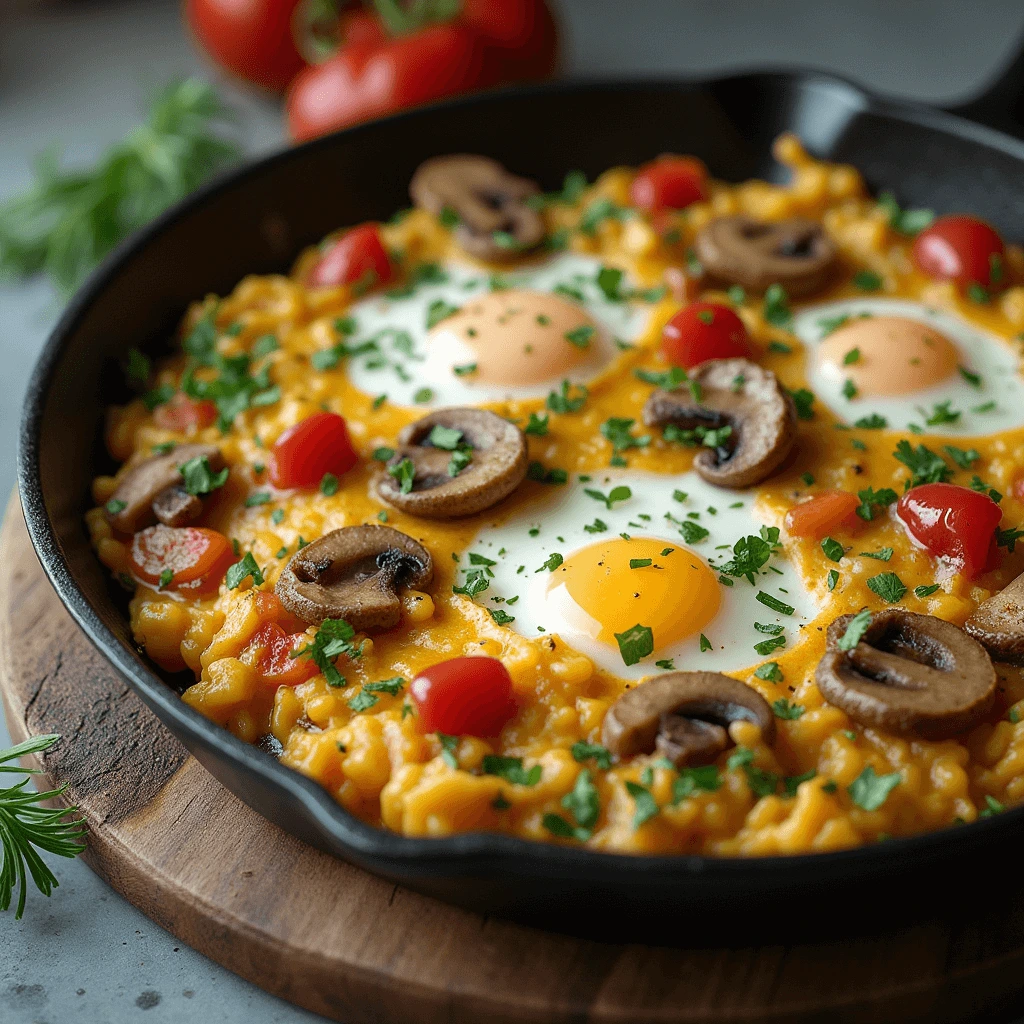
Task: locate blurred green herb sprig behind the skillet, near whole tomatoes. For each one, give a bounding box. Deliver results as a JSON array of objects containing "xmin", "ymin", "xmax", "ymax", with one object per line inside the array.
[{"xmin": 0, "ymin": 79, "xmax": 240, "ymax": 293}]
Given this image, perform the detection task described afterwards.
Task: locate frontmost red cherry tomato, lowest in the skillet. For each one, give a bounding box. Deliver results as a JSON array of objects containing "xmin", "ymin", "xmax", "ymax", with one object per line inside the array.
[{"xmin": 410, "ymin": 657, "xmax": 516, "ymax": 736}]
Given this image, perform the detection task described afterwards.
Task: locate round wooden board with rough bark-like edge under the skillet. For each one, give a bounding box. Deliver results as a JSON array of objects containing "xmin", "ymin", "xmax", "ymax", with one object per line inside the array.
[{"xmin": 6, "ymin": 491, "xmax": 1024, "ymax": 1024}]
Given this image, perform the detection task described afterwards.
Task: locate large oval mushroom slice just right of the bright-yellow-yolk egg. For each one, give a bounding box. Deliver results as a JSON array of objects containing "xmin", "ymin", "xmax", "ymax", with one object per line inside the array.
[{"xmin": 815, "ymin": 608, "xmax": 995, "ymax": 739}]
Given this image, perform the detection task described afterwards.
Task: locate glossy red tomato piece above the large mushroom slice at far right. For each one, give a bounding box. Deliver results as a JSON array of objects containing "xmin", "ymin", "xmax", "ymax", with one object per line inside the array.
[{"xmin": 896, "ymin": 483, "xmax": 1002, "ymax": 580}]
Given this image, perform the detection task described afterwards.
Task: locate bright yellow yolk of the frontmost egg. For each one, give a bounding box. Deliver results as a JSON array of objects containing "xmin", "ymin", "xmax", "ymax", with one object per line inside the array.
[{"xmin": 547, "ymin": 537, "xmax": 721, "ymax": 650}]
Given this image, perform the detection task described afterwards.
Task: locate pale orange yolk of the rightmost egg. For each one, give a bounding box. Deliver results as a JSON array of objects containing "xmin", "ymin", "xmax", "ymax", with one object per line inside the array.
[{"xmin": 818, "ymin": 316, "xmax": 961, "ymax": 396}]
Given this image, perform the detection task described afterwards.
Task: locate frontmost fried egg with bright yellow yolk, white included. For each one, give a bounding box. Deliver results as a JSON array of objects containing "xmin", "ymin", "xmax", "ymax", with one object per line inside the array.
[{"xmin": 452, "ymin": 471, "xmax": 818, "ymax": 680}]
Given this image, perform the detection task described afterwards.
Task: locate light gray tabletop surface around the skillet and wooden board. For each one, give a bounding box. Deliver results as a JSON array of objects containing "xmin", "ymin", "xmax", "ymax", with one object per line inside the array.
[{"xmin": 0, "ymin": 0, "xmax": 1024, "ymax": 1024}]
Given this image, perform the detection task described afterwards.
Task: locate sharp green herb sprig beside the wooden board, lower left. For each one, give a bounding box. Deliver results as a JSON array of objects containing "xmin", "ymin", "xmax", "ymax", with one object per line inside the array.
[{"xmin": 0, "ymin": 734, "xmax": 86, "ymax": 921}]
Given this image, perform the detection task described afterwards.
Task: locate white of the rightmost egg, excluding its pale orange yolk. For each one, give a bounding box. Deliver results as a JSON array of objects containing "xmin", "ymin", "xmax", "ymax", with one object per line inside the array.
[{"xmin": 793, "ymin": 299, "xmax": 1024, "ymax": 436}]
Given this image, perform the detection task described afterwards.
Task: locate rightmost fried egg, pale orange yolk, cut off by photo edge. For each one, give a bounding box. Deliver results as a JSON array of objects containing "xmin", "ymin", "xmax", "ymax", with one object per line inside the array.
[{"xmin": 794, "ymin": 299, "xmax": 1024, "ymax": 436}]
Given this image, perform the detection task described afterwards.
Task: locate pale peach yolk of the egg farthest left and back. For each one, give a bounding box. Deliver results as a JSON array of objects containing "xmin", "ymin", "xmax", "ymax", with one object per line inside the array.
[{"xmin": 429, "ymin": 289, "xmax": 598, "ymax": 387}]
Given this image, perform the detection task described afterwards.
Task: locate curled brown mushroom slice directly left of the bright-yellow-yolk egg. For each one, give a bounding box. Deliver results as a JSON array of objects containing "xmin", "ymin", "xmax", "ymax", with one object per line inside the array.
[{"xmin": 274, "ymin": 526, "xmax": 434, "ymax": 631}]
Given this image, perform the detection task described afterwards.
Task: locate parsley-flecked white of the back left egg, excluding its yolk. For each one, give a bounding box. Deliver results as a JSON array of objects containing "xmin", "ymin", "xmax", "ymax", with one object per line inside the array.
[{"xmin": 346, "ymin": 253, "xmax": 649, "ymax": 409}]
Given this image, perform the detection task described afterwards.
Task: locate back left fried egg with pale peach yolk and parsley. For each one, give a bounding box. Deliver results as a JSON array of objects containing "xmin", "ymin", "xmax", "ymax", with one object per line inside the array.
[{"xmin": 333, "ymin": 254, "xmax": 649, "ymax": 408}]
